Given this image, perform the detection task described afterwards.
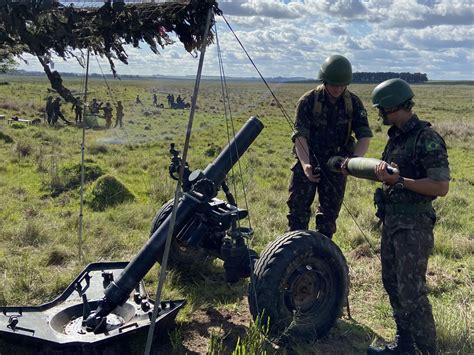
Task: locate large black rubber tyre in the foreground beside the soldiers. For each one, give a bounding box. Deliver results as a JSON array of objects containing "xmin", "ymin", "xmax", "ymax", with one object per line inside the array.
[{"xmin": 248, "ymin": 230, "xmax": 349, "ymax": 344}]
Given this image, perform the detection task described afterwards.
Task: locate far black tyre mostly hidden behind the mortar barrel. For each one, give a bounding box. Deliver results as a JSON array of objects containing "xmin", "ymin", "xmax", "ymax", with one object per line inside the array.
[{"xmin": 150, "ymin": 200, "xmax": 211, "ymax": 268}]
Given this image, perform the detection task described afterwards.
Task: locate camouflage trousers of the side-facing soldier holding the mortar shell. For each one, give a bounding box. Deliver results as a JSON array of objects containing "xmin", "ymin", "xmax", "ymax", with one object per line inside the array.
[{"xmin": 380, "ymin": 215, "xmax": 436, "ymax": 355}]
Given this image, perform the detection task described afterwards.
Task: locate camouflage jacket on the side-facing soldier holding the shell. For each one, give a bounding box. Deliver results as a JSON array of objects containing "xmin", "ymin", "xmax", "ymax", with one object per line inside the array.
[{"xmin": 382, "ymin": 115, "xmax": 450, "ymax": 204}]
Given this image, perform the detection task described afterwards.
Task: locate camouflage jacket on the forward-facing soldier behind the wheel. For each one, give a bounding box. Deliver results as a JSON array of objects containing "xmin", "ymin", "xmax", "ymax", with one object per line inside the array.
[{"xmin": 292, "ymin": 89, "xmax": 373, "ymax": 157}]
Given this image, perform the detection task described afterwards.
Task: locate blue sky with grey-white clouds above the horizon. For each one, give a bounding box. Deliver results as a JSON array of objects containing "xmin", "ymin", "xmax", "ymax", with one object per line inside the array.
[{"xmin": 16, "ymin": 0, "xmax": 474, "ymax": 80}]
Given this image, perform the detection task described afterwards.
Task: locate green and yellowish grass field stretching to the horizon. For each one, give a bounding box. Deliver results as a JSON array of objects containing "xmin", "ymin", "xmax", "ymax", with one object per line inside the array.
[{"xmin": 0, "ymin": 76, "xmax": 474, "ymax": 354}]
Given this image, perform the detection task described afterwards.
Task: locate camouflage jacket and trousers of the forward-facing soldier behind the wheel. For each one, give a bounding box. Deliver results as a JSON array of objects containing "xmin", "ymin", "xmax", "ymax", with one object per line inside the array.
[{"xmin": 287, "ymin": 88, "xmax": 372, "ymax": 237}]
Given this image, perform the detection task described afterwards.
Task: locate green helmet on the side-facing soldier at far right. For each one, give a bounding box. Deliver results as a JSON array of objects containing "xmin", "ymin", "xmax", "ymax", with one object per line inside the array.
[{"xmin": 372, "ymin": 79, "xmax": 415, "ymax": 108}]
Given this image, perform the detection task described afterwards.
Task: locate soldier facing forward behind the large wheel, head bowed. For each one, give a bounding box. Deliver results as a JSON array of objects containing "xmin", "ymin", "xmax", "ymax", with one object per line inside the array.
[{"xmin": 287, "ymin": 55, "xmax": 372, "ymax": 238}]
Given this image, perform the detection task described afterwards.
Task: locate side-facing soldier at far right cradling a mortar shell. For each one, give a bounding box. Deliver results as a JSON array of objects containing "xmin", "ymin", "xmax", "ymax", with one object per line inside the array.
[{"xmin": 367, "ymin": 79, "xmax": 450, "ymax": 355}]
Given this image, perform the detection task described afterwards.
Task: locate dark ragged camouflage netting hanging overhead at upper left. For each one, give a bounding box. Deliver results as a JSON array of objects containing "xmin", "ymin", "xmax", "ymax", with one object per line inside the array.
[{"xmin": 0, "ymin": 0, "xmax": 220, "ymax": 102}]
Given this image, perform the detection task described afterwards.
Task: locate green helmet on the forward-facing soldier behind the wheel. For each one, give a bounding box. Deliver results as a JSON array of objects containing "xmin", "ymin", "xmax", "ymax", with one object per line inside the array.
[{"xmin": 318, "ymin": 54, "xmax": 352, "ymax": 86}]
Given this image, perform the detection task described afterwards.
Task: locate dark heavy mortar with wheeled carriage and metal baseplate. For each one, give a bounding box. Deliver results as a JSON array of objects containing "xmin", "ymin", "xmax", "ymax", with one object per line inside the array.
[{"xmin": 0, "ymin": 117, "xmax": 348, "ymax": 354}]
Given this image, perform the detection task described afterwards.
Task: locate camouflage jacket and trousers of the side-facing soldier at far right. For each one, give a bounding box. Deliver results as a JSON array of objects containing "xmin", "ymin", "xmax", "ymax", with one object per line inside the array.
[{"xmin": 378, "ymin": 115, "xmax": 449, "ymax": 354}]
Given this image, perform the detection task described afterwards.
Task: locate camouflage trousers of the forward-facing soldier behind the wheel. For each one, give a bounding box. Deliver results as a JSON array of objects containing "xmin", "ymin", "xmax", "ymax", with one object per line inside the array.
[{"xmin": 286, "ymin": 161, "xmax": 347, "ymax": 238}]
